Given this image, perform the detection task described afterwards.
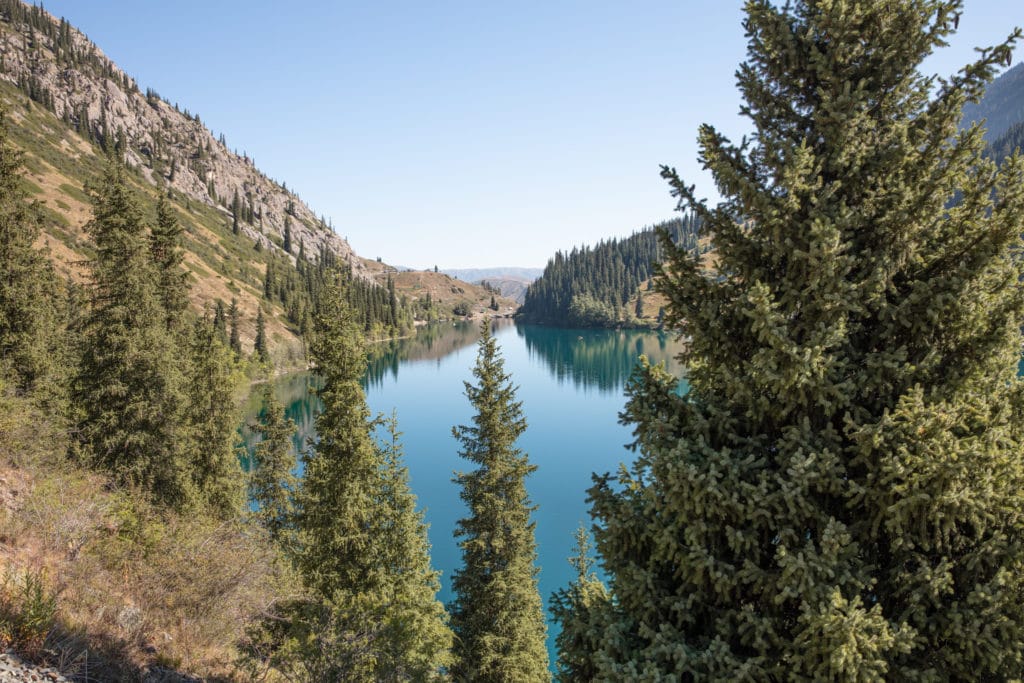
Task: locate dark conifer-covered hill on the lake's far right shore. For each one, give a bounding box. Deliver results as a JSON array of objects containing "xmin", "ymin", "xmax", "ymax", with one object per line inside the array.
[{"xmin": 518, "ymin": 214, "xmax": 700, "ymax": 328}]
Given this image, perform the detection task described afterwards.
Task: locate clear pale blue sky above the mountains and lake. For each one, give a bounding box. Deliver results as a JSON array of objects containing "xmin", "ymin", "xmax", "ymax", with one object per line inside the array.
[{"xmin": 36, "ymin": 0, "xmax": 1024, "ymax": 268}]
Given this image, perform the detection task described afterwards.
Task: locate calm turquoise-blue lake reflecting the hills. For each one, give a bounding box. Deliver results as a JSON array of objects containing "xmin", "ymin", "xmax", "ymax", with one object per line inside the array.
[{"xmin": 241, "ymin": 321, "xmax": 682, "ymax": 661}]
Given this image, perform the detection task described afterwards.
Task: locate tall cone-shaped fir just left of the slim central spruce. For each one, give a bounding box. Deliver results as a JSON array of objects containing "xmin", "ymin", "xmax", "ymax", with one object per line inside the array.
[{"xmin": 296, "ymin": 274, "xmax": 451, "ymax": 681}]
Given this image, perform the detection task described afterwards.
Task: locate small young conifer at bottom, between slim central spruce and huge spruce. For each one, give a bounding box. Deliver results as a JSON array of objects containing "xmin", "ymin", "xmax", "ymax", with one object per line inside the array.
[{"xmin": 551, "ymin": 524, "xmax": 608, "ymax": 683}]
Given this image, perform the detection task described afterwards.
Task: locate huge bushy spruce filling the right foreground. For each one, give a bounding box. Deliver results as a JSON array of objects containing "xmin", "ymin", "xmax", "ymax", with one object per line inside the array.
[{"xmin": 591, "ymin": 0, "xmax": 1024, "ymax": 681}]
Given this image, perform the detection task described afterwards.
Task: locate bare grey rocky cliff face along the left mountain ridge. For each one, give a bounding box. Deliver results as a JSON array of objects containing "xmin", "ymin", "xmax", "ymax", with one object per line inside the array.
[{"xmin": 0, "ymin": 0, "xmax": 367, "ymax": 276}]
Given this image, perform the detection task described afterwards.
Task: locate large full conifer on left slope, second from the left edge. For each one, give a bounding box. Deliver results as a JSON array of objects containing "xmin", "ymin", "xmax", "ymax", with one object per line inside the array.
[{"xmin": 75, "ymin": 162, "xmax": 191, "ymax": 504}]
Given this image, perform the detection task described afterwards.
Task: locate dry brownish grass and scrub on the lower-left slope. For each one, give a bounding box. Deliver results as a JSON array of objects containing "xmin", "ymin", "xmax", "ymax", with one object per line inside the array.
[{"xmin": 0, "ymin": 387, "xmax": 296, "ymax": 681}]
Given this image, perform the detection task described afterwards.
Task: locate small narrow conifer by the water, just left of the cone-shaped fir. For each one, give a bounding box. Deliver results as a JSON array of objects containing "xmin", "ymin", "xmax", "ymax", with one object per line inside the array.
[{"xmin": 249, "ymin": 382, "xmax": 298, "ymax": 549}]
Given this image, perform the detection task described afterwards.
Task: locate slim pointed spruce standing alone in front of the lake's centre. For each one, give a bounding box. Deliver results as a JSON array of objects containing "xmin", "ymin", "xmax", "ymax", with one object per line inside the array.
[{"xmin": 452, "ymin": 321, "xmax": 551, "ymax": 683}]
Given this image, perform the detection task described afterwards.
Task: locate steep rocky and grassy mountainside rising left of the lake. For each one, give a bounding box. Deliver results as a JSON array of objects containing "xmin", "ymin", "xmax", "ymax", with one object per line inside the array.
[{"xmin": 0, "ymin": 0, "xmax": 510, "ymax": 367}]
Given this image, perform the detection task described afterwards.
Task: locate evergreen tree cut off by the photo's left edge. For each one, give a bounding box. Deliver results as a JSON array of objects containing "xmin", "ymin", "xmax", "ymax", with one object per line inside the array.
[{"xmin": 0, "ymin": 112, "xmax": 56, "ymax": 390}]
